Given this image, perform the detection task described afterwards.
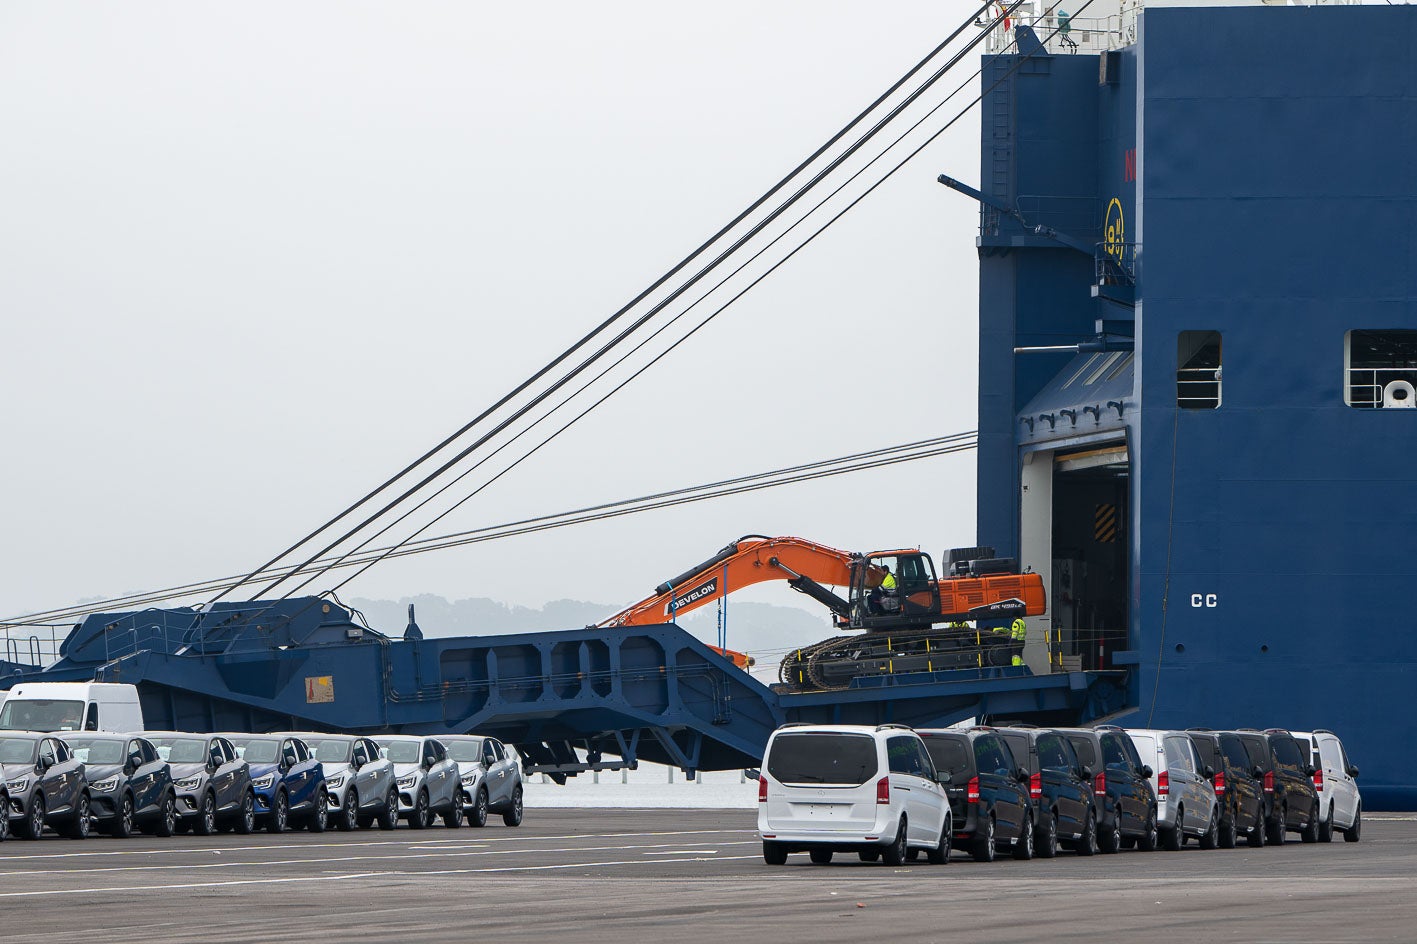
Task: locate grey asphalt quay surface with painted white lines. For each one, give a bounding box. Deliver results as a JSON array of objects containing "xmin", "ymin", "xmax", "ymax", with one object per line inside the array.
[{"xmin": 0, "ymin": 809, "xmax": 1417, "ymax": 944}]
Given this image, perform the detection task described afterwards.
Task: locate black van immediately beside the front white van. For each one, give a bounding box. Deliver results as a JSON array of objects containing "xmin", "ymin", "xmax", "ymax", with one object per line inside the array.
[{"xmin": 915, "ymin": 727, "xmax": 1033, "ymax": 862}]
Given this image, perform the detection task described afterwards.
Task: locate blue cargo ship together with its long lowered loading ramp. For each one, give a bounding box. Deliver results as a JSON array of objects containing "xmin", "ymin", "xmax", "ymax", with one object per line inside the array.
[{"xmin": 0, "ymin": 0, "xmax": 1417, "ymax": 809}]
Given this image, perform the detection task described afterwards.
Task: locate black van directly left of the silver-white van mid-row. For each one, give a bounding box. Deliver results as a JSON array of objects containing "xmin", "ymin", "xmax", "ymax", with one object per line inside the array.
[{"xmin": 1058, "ymin": 726, "xmax": 1159, "ymax": 853}]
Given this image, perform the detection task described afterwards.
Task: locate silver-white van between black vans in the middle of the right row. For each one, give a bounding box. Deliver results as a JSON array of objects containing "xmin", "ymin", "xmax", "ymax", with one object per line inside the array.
[{"xmin": 1127, "ymin": 729, "xmax": 1220, "ymax": 849}]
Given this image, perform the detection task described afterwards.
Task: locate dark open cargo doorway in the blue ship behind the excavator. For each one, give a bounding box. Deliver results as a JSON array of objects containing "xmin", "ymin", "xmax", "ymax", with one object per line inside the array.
[{"xmin": 1049, "ymin": 442, "xmax": 1129, "ymax": 670}]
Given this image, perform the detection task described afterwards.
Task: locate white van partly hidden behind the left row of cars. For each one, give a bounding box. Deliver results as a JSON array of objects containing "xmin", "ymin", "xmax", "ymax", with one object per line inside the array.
[{"xmin": 0, "ymin": 682, "xmax": 143, "ymax": 734}]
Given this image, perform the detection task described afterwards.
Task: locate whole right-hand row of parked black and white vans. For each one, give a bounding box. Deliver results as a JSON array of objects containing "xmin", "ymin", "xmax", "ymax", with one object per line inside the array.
[{"xmin": 758, "ymin": 724, "xmax": 1363, "ymax": 865}]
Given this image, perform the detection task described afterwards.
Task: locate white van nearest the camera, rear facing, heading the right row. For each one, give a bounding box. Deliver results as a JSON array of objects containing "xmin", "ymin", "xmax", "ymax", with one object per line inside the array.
[{"xmin": 758, "ymin": 724, "xmax": 952, "ymax": 866}]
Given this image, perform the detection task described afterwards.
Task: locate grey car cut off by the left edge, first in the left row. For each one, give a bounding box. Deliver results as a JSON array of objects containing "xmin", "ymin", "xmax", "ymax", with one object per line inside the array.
[{"xmin": 0, "ymin": 731, "xmax": 94, "ymax": 839}]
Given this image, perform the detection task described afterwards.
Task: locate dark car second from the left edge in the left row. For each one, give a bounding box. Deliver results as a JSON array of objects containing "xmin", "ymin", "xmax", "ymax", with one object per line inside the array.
[{"xmin": 60, "ymin": 731, "xmax": 177, "ymax": 839}]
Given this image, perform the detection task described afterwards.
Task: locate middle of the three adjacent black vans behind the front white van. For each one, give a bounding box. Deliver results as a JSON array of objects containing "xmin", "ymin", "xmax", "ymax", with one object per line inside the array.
[{"xmin": 998, "ymin": 727, "xmax": 1097, "ymax": 859}]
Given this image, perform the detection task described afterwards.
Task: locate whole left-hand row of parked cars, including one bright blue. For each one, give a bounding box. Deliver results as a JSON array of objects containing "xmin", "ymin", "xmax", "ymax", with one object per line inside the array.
[{"xmin": 0, "ymin": 731, "xmax": 523, "ymax": 839}]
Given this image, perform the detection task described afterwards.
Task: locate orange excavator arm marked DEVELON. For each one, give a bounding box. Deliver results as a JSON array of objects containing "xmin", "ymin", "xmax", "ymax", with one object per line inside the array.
[{"xmin": 599, "ymin": 534, "xmax": 854, "ymax": 626}]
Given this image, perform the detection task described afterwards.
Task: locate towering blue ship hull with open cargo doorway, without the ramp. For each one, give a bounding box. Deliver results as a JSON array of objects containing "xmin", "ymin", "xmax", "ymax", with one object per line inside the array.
[{"xmin": 978, "ymin": 3, "xmax": 1417, "ymax": 809}]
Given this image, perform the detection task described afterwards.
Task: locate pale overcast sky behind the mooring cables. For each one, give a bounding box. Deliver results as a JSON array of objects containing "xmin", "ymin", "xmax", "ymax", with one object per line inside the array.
[{"xmin": 0, "ymin": 0, "xmax": 979, "ymax": 629}]
